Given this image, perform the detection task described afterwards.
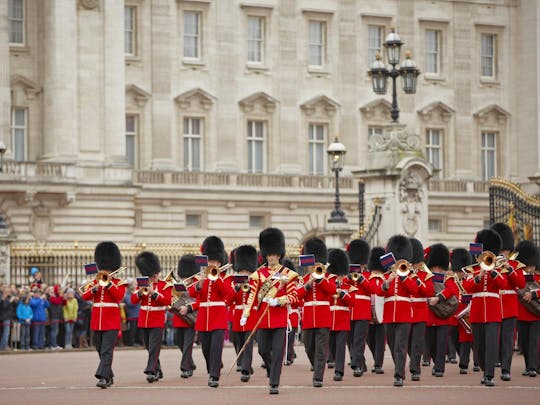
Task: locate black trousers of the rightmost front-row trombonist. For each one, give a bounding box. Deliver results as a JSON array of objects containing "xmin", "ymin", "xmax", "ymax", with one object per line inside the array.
[{"xmin": 472, "ymin": 322, "xmax": 500, "ymax": 379}]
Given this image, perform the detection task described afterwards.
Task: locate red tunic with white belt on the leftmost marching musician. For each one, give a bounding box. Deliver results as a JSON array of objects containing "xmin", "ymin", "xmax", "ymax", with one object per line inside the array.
[{"xmin": 82, "ymin": 277, "xmax": 127, "ymax": 331}]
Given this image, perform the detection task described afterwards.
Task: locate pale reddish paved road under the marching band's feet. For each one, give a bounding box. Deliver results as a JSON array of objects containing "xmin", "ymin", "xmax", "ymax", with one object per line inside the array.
[{"xmin": 0, "ymin": 346, "xmax": 540, "ymax": 405}]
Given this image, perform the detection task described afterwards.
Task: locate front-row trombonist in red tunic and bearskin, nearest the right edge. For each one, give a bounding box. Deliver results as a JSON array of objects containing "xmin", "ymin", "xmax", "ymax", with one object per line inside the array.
[{"xmin": 463, "ymin": 229, "xmax": 505, "ymax": 387}]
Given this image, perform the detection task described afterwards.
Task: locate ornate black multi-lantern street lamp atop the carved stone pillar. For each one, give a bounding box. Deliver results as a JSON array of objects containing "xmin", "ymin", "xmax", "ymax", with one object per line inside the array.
[{"xmin": 368, "ymin": 29, "xmax": 420, "ymax": 122}]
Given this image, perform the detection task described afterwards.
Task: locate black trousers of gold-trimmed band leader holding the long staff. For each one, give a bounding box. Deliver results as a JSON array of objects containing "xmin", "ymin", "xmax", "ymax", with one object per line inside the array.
[{"xmin": 257, "ymin": 328, "xmax": 288, "ymax": 387}]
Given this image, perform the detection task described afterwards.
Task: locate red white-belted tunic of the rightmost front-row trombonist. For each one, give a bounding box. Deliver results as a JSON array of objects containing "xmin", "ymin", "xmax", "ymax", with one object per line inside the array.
[{"xmin": 463, "ymin": 266, "xmax": 504, "ymax": 323}]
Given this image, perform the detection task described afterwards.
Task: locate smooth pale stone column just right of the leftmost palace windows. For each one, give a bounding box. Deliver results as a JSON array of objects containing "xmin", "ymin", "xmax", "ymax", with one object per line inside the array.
[{"xmin": 42, "ymin": 0, "xmax": 78, "ymax": 161}]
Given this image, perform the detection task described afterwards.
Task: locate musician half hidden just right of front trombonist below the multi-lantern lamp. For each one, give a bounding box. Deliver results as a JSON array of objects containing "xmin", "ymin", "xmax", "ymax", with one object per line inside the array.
[{"xmin": 408, "ymin": 238, "xmax": 435, "ymax": 381}]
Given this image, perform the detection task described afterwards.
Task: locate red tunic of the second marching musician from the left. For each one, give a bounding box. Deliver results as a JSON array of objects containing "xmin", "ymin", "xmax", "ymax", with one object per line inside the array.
[{"xmin": 131, "ymin": 280, "xmax": 172, "ymax": 328}]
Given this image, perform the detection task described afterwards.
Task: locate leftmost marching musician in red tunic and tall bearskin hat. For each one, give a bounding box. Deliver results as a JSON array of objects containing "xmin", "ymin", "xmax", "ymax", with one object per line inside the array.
[{"xmin": 82, "ymin": 242, "xmax": 127, "ymax": 388}]
